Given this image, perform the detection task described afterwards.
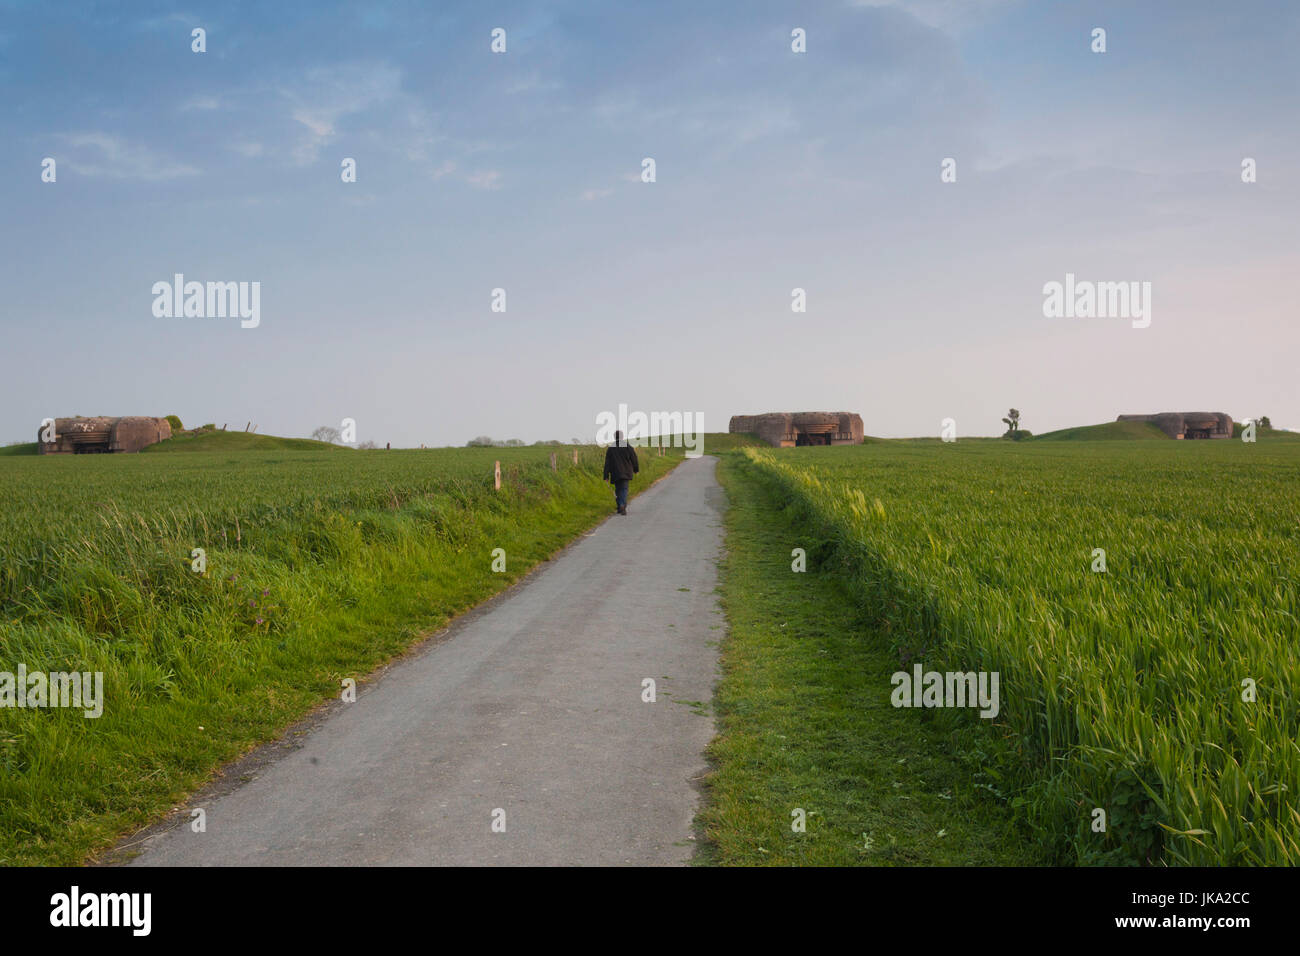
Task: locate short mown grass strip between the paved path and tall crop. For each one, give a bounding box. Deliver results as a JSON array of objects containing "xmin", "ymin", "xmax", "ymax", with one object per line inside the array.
[{"xmin": 699, "ymin": 455, "xmax": 1044, "ymax": 865}]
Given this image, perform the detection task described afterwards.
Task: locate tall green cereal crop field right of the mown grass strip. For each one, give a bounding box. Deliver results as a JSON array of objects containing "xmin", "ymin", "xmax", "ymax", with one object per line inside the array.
[{"xmin": 740, "ymin": 441, "xmax": 1300, "ymax": 865}]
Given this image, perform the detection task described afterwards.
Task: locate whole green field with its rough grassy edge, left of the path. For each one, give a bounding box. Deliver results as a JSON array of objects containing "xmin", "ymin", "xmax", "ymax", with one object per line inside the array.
[{"xmin": 0, "ymin": 445, "xmax": 680, "ymax": 865}]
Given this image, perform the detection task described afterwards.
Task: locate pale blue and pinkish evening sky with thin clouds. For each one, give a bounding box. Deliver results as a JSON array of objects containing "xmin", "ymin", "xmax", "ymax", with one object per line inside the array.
[{"xmin": 0, "ymin": 0, "xmax": 1300, "ymax": 447}]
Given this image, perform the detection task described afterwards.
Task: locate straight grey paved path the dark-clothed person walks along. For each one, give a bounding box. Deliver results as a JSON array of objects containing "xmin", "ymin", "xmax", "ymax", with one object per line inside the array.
[{"xmin": 130, "ymin": 458, "xmax": 725, "ymax": 866}]
